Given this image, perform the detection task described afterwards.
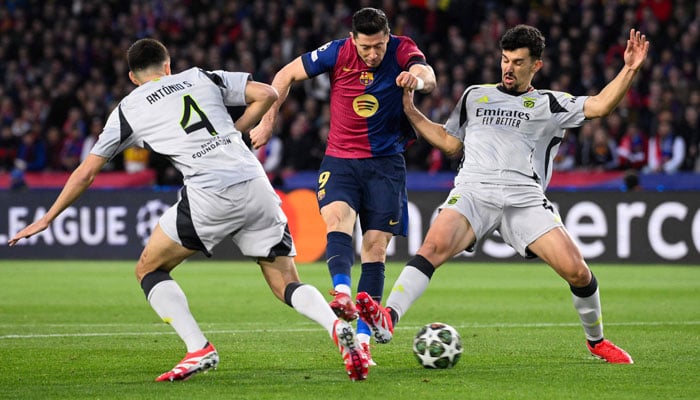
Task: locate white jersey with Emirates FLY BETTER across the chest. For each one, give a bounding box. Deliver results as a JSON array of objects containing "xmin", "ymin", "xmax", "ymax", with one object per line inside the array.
[{"xmin": 444, "ymin": 85, "xmax": 587, "ymax": 190}]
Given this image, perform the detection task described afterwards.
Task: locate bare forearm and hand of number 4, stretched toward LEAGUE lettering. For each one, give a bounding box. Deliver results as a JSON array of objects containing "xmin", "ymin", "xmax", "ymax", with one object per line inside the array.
[{"xmin": 7, "ymin": 154, "xmax": 107, "ymax": 246}]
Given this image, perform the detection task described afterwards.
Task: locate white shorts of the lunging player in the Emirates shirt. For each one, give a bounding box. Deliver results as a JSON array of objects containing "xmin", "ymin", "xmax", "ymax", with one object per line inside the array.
[{"xmin": 440, "ymin": 182, "xmax": 563, "ymax": 257}]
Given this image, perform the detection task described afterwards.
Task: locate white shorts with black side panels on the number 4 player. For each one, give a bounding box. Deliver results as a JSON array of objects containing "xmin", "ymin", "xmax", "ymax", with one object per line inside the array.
[{"xmin": 159, "ymin": 177, "xmax": 296, "ymax": 258}]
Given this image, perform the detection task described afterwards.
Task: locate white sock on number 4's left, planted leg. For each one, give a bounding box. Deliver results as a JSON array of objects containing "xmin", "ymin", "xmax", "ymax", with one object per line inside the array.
[{"xmin": 148, "ymin": 280, "xmax": 207, "ymax": 353}]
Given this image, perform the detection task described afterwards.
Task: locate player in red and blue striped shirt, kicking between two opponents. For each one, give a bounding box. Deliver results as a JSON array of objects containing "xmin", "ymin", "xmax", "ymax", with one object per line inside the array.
[{"xmin": 250, "ymin": 8, "xmax": 435, "ymax": 364}]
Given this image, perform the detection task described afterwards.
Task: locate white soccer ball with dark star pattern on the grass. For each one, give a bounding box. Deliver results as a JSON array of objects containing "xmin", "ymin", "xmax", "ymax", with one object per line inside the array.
[{"xmin": 413, "ymin": 322, "xmax": 462, "ymax": 369}]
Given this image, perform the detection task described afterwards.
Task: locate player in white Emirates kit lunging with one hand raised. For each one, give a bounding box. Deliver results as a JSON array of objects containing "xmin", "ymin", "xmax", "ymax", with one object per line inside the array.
[{"xmin": 361, "ymin": 25, "xmax": 649, "ymax": 364}]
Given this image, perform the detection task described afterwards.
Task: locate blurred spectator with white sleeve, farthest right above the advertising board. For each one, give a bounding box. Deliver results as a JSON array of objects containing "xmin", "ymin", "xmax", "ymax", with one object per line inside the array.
[{"xmin": 644, "ymin": 121, "xmax": 685, "ymax": 174}]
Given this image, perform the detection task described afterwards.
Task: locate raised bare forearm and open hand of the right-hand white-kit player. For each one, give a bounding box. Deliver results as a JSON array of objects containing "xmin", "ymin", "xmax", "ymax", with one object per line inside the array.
[{"xmin": 583, "ymin": 29, "xmax": 649, "ymax": 119}]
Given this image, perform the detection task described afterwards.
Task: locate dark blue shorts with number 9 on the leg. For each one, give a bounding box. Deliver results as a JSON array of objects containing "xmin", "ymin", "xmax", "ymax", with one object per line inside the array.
[{"xmin": 316, "ymin": 154, "xmax": 408, "ymax": 236}]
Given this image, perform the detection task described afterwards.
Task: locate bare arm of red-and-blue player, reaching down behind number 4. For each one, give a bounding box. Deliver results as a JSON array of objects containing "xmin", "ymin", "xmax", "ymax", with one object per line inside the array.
[{"xmin": 250, "ymin": 57, "xmax": 309, "ymax": 149}]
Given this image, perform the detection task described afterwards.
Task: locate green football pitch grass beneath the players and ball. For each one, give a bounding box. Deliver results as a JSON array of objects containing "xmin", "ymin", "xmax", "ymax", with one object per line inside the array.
[{"xmin": 0, "ymin": 260, "xmax": 700, "ymax": 400}]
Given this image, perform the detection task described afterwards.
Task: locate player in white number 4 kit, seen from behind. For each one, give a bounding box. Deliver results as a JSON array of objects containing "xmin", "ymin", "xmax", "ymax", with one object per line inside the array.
[{"xmin": 9, "ymin": 39, "xmax": 368, "ymax": 381}]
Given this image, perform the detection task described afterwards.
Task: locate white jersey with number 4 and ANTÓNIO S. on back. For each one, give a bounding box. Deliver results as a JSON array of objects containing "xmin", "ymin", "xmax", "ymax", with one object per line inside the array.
[{"xmin": 91, "ymin": 68, "xmax": 265, "ymax": 189}]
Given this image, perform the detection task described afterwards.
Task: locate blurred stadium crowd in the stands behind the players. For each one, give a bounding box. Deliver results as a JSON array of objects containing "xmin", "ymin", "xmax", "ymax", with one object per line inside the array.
[{"xmin": 0, "ymin": 0, "xmax": 700, "ymax": 184}]
